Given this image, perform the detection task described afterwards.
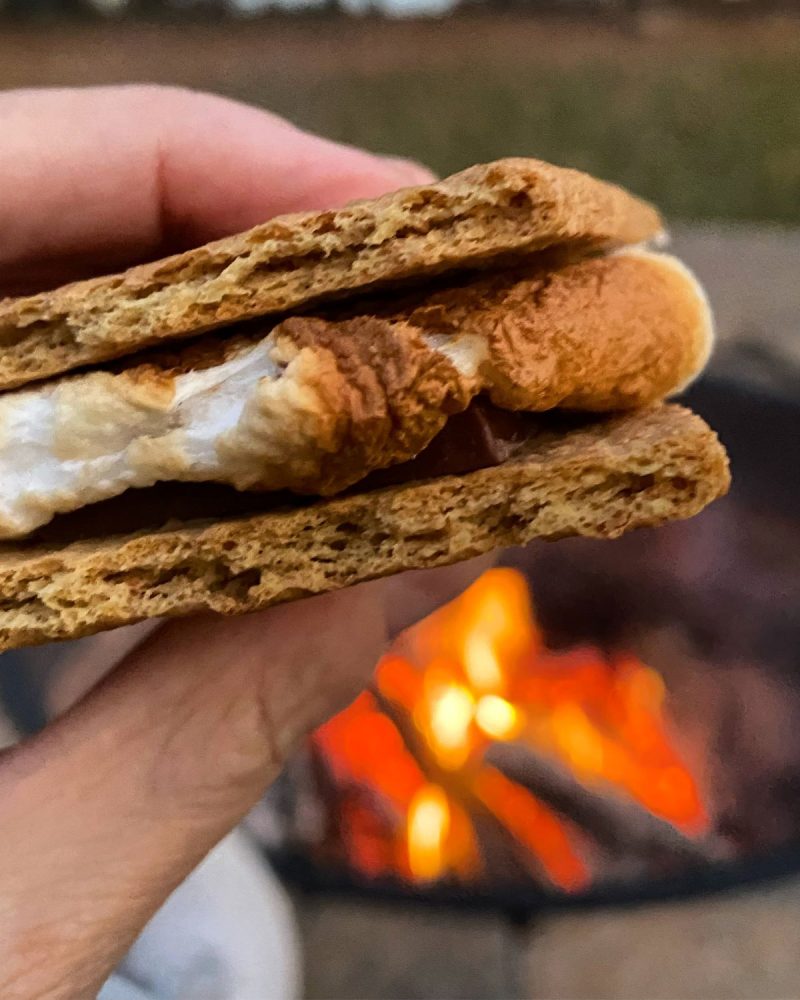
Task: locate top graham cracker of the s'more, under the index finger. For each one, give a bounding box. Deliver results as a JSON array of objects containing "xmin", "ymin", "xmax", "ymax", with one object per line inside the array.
[{"xmin": 0, "ymin": 159, "xmax": 662, "ymax": 390}]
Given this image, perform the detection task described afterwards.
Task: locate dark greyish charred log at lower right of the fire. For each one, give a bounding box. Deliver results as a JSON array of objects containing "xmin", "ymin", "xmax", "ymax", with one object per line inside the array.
[{"xmin": 484, "ymin": 742, "xmax": 724, "ymax": 865}]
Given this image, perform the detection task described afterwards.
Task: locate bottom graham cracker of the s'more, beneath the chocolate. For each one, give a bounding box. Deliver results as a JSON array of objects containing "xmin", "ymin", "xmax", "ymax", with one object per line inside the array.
[{"xmin": 0, "ymin": 405, "xmax": 729, "ymax": 649}]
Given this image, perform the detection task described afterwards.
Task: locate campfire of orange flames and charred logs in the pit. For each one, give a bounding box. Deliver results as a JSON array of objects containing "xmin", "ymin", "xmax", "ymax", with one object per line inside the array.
[{"xmin": 307, "ymin": 569, "xmax": 723, "ymax": 893}]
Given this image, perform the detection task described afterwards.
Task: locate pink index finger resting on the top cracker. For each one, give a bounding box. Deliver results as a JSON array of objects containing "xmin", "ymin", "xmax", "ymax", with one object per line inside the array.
[{"xmin": 0, "ymin": 86, "xmax": 430, "ymax": 294}]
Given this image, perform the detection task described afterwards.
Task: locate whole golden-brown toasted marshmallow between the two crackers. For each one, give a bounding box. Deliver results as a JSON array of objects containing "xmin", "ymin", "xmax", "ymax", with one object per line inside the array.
[{"xmin": 0, "ymin": 250, "xmax": 711, "ymax": 538}]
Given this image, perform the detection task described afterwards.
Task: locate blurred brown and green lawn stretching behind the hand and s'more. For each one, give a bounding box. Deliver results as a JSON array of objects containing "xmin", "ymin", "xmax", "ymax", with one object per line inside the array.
[{"xmin": 0, "ymin": 14, "xmax": 800, "ymax": 226}]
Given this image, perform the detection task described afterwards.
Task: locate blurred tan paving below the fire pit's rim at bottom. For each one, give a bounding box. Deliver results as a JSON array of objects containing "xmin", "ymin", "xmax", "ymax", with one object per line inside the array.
[{"xmin": 298, "ymin": 878, "xmax": 800, "ymax": 1000}]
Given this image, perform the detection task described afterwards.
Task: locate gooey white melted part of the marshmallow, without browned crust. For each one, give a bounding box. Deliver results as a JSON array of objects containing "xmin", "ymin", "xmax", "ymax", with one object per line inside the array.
[{"xmin": 0, "ymin": 335, "xmax": 485, "ymax": 538}]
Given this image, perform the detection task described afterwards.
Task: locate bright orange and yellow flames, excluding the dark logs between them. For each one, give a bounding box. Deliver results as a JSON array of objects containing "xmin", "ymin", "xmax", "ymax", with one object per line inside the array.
[{"xmin": 317, "ymin": 569, "xmax": 709, "ymax": 891}]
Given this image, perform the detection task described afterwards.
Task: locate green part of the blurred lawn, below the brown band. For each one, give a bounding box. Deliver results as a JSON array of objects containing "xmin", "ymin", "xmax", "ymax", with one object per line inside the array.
[{"xmin": 234, "ymin": 49, "xmax": 800, "ymax": 225}]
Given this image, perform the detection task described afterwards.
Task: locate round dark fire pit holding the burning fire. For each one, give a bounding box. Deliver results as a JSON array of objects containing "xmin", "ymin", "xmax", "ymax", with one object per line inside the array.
[{"xmin": 261, "ymin": 370, "xmax": 800, "ymax": 911}]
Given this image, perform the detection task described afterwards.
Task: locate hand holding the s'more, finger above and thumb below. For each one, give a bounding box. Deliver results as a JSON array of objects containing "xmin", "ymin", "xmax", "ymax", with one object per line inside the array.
[{"xmin": 0, "ymin": 87, "xmax": 485, "ymax": 1000}]
